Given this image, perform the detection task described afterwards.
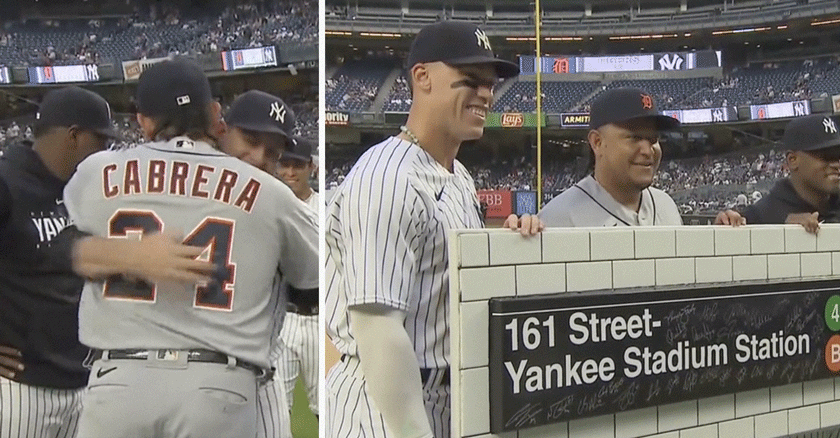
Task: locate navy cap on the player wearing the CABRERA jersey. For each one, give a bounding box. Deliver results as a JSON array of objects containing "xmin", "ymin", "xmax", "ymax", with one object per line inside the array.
[{"xmin": 136, "ymin": 58, "xmax": 213, "ymax": 117}]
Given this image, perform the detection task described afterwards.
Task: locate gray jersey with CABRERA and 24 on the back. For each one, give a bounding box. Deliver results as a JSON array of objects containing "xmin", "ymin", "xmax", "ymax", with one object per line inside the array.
[{"xmin": 64, "ymin": 137, "xmax": 318, "ymax": 367}]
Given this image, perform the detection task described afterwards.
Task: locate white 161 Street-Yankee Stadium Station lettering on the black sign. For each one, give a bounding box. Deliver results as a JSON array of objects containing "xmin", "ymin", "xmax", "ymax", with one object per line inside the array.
[{"xmin": 504, "ymin": 308, "xmax": 811, "ymax": 394}]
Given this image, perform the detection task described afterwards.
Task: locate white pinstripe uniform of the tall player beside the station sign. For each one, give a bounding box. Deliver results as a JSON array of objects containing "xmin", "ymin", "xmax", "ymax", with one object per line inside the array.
[{"xmin": 325, "ymin": 137, "xmax": 482, "ymax": 438}]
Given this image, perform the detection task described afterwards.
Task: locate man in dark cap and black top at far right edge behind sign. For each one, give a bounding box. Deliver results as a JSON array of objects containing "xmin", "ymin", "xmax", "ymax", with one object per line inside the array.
[{"xmin": 743, "ymin": 114, "xmax": 840, "ymax": 234}]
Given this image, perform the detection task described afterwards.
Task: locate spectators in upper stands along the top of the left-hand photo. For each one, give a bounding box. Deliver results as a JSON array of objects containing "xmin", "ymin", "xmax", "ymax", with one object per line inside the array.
[{"xmin": 0, "ymin": 0, "xmax": 318, "ymax": 66}]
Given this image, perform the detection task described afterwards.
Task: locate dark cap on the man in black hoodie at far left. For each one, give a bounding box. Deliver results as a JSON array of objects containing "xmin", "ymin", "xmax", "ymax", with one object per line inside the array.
[{"xmin": 35, "ymin": 87, "xmax": 120, "ymax": 138}]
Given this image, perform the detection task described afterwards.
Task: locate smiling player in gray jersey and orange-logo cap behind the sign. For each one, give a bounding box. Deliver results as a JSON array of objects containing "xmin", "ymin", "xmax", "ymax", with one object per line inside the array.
[{"xmin": 539, "ymin": 88, "xmax": 743, "ymax": 227}]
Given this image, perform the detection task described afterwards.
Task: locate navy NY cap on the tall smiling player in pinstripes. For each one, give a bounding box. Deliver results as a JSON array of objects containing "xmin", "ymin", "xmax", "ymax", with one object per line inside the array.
[{"xmin": 406, "ymin": 21, "xmax": 519, "ymax": 78}]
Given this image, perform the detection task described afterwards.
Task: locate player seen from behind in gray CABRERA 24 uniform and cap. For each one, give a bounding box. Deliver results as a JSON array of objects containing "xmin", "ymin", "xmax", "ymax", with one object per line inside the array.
[{"xmin": 64, "ymin": 60, "xmax": 317, "ymax": 438}]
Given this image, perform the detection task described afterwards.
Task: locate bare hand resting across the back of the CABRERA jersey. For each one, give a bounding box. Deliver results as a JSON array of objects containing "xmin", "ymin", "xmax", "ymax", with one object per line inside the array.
[{"xmin": 123, "ymin": 233, "xmax": 216, "ymax": 283}]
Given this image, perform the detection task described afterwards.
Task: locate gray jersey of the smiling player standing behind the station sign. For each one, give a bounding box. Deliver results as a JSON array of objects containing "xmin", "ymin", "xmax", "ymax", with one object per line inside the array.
[{"xmin": 539, "ymin": 175, "xmax": 682, "ymax": 227}]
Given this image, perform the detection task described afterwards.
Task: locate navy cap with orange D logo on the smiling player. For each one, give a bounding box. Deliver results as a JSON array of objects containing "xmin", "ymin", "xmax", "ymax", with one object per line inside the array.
[{"xmin": 589, "ymin": 88, "xmax": 680, "ymax": 131}]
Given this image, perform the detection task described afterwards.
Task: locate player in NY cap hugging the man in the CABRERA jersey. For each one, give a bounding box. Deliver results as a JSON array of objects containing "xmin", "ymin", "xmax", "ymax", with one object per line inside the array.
[{"xmin": 221, "ymin": 90, "xmax": 306, "ymax": 438}]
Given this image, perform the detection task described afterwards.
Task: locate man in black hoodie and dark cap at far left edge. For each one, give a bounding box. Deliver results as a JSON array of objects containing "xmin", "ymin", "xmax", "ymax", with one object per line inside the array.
[{"xmin": 0, "ymin": 87, "xmax": 116, "ymax": 438}]
